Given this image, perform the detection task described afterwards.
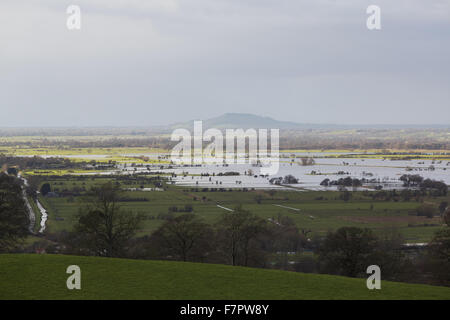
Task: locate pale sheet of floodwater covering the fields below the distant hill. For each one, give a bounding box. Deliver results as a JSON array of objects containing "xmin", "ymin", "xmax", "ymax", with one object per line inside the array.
[{"xmin": 115, "ymin": 153, "xmax": 450, "ymax": 190}]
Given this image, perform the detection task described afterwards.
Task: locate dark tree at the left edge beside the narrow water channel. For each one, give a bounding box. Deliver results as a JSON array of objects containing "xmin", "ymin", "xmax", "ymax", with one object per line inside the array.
[{"xmin": 0, "ymin": 173, "xmax": 29, "ymax": 252}]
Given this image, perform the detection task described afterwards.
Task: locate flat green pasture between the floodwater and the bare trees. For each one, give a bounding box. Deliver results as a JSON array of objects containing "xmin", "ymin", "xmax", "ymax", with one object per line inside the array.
[{"xmin": 37, "ymin": 178, "xmax": 450, "ymax": 242}]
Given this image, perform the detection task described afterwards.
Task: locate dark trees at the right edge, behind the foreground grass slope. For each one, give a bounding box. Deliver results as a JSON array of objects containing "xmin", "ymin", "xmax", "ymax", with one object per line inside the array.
[{"xmin": 316, "ymin": 210, "xmax": 450, "ymax": 286}]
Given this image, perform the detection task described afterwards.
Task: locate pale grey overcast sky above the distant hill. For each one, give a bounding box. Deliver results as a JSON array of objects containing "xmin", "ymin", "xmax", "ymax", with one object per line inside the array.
[{"xmin": 0, "ymin": 0, "xmax": 450, "ymax": 126}]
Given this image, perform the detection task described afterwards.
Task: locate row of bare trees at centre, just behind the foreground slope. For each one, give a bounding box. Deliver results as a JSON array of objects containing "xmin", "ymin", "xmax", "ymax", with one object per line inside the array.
[{"xmin": 136, "ymin": 207, "xmax": 307, "ymax": 267}]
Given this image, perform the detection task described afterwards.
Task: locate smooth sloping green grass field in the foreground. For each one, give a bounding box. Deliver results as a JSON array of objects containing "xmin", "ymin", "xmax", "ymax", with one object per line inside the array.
[{"xmin": 0, "ymin": 254, "xmax": 450, "ymax": 300}]
